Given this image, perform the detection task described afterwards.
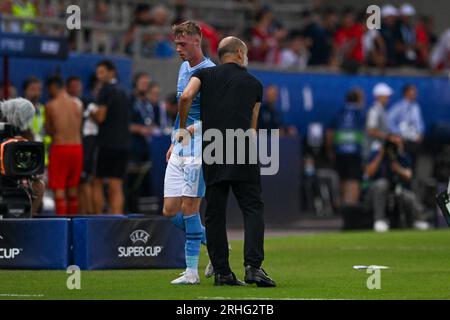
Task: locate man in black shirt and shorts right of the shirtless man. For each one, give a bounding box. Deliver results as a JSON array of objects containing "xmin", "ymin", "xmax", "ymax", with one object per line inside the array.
[{"xmin": 91, "ymin": 60, "xmax": 131, "ymax": 214}]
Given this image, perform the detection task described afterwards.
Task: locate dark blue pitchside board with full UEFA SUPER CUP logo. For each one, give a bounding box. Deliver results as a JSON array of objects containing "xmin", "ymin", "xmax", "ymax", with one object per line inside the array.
[{"xmin": 72, "ymin": 218, "xmax": 185, "ymax": 270}]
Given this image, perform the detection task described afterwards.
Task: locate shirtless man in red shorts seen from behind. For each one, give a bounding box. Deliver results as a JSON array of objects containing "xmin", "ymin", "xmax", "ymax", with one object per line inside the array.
[{"xmin": 45, "ymin": 76, "xmax": 83, "ymax": 215}]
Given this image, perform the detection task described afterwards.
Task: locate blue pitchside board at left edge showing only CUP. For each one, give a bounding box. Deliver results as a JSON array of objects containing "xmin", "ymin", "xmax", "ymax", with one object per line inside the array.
[{"xmin": 0, "ymin": 219, "xmax": 70, "ymax": 269}]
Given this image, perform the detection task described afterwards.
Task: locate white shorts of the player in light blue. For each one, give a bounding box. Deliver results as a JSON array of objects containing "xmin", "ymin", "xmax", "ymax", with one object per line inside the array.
[{"xmin": 164, "ymin": 153, "xmax": 205, "ymax": 198}]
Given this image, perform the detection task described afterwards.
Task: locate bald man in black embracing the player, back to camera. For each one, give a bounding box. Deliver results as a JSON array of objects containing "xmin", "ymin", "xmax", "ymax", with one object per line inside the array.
[{"xmin": 178, "ymin": 37, "xmax": 275, "ymax": 287}]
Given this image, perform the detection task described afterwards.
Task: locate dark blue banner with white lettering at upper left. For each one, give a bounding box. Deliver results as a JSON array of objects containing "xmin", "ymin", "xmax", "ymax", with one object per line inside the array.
[{"xmin": 0, "ymin": 32, "xmax": 69, "ymax": 59}]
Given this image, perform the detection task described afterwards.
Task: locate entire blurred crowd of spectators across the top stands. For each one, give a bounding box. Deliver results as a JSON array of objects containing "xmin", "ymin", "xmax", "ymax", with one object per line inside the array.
[{"xmin": 0, "ymin": 0, "xmax": 450, "ymax": 72}]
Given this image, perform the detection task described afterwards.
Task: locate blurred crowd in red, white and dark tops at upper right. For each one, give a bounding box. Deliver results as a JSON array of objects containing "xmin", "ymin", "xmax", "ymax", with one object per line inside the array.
[{"xmin": 247, "ymin": 4, "xmax": 448, "ymax": 72}]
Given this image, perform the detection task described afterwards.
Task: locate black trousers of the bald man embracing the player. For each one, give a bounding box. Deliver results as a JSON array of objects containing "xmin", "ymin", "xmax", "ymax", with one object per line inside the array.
[{"xmin": 205, "ymin": 181, "xmax": 264, "ymax": 275}]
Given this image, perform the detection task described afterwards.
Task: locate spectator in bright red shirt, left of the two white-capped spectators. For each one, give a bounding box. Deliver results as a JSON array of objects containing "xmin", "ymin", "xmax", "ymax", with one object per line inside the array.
[{"xmin": 334, "ymin": 8, "xmax": 364, "ymax": 73}]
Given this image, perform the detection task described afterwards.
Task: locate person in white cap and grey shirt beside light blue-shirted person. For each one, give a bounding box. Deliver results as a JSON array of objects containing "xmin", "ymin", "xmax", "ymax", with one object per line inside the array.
[{"xmin": 366, "ymin": 83, "xmax": 393, "ymax": 151}]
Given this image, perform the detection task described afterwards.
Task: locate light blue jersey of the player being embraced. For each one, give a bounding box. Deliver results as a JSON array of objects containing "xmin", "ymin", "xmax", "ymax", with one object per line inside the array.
[{"xmin": 172, "ymin": 58, "xmax": 215, "ymax": 156}]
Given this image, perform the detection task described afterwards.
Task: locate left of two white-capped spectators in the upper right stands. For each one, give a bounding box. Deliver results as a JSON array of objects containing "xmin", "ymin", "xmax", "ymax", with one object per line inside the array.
[{"xmin": 380, "ymin": 4, "xmax": 398, "ymax": 67}]
